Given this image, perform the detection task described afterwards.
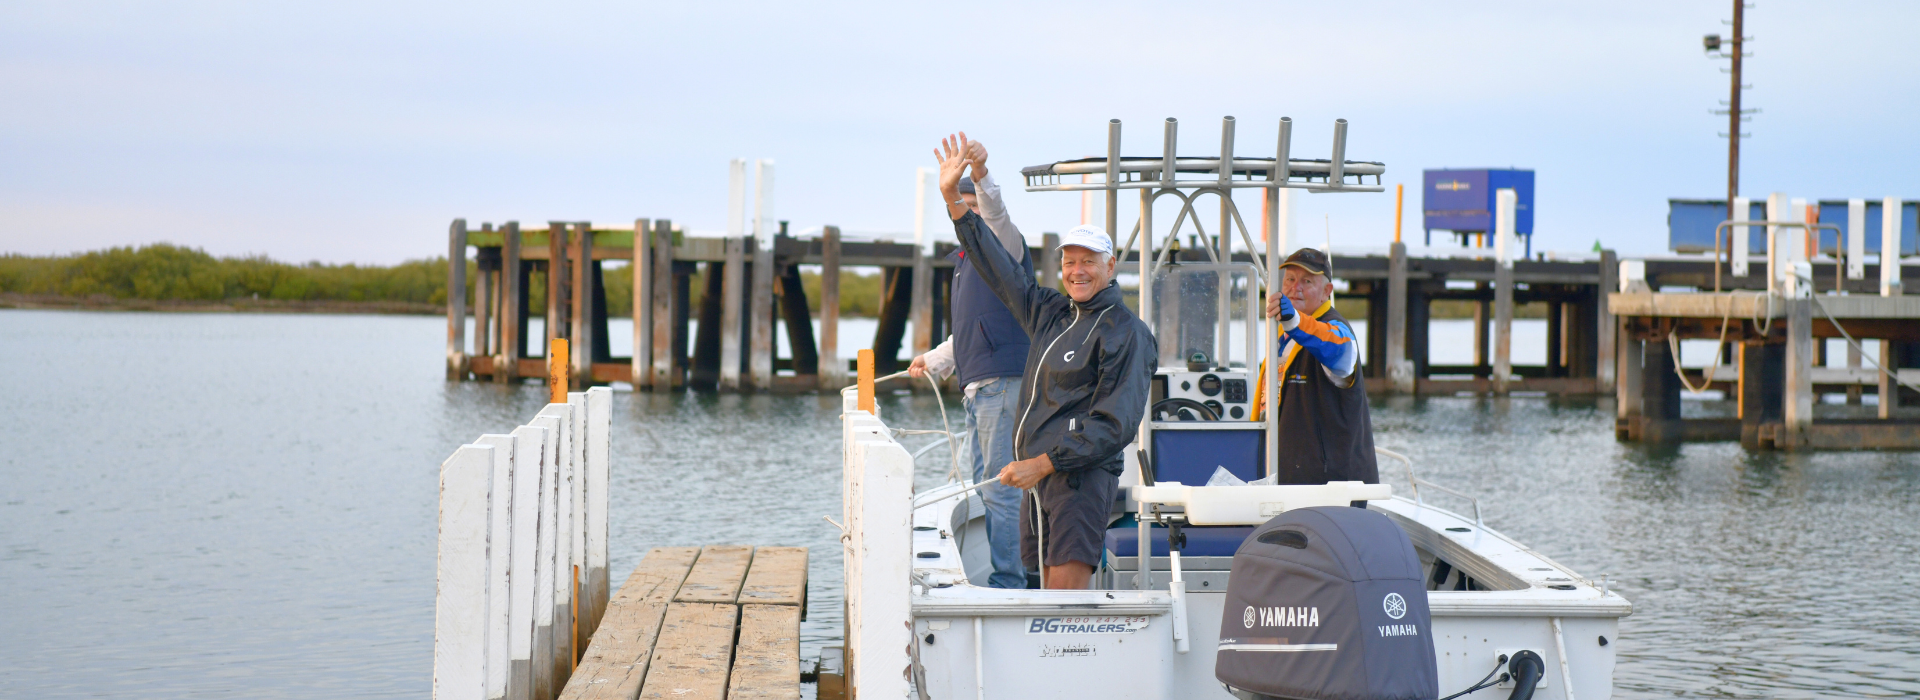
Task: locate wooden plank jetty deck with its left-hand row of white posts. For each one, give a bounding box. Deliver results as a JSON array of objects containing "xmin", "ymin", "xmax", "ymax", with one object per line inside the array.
[{"xmin": 434, "ymin": 381, "xmax": 806, "ymax": 700}]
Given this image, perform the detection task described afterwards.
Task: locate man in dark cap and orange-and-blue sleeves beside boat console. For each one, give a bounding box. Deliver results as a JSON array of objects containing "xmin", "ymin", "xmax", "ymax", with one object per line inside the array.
[{"xmin": 1254, "ymin": 247, "xmax": 1380, "ymax": 483}]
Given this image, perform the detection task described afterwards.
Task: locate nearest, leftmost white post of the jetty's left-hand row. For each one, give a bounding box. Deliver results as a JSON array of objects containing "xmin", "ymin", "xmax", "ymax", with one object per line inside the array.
[{"xmin": 434, "ymin": 445, "xmax": 493, "ymax": 700}]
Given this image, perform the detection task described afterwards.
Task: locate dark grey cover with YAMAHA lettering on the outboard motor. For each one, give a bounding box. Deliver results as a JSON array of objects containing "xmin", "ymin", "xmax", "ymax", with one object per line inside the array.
[{"xmin": 1213, "ymin": 506, "xmax": 1440, "ymax": 700}]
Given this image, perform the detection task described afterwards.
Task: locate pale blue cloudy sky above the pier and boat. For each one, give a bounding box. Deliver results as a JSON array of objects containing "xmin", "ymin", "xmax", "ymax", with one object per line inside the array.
[{"xmin": 0, "ymin": 0, "xmax": 1920, "ymax": 265}]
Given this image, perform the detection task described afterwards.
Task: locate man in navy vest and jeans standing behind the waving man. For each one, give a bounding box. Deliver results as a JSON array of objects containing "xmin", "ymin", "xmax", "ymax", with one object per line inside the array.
[{"xmin": 906, "ymin": 142, "xmax": 1033, "ymax": 589}]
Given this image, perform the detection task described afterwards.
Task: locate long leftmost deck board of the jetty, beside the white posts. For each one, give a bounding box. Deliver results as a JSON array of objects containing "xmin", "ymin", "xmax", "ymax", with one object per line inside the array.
[{"xmin": 561, "ymin": 547, "xmax": 699, "ymax": 700}]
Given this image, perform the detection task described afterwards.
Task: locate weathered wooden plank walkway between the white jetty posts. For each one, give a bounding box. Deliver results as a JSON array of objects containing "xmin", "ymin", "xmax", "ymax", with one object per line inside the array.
[{"xmin": 561, "ymin": 545, "xmax": 806, "ymax": 700}]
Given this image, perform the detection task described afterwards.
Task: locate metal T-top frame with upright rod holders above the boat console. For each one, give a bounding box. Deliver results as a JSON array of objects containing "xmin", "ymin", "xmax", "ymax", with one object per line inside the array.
[{"xmin": 1020, "ymin": 117, "xmax": 1386, "ymax": 468}]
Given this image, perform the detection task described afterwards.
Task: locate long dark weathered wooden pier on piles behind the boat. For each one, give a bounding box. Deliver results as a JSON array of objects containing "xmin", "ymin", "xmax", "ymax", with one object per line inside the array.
[{"xmin": 447, "ymin": 219, "xmax": 1666, "ymax": 395}]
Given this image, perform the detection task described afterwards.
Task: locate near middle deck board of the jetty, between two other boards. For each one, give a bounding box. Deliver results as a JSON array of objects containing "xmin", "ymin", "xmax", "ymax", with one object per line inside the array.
[{"xmin": 639, "ymin": 602, "xmax": 739, "ymax": 700}]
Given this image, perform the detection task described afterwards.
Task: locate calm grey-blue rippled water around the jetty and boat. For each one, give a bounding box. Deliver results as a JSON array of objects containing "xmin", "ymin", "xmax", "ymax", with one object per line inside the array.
[{"xmin": 0, "ymin": 311, "xmax": 1920, "ymax": 698}]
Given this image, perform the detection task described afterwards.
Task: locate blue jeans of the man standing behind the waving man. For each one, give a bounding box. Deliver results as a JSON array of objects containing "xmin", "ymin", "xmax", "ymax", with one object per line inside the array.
[{"xmin": 966, "ymin": 376, "xmax": 1027, "ymax": 589}]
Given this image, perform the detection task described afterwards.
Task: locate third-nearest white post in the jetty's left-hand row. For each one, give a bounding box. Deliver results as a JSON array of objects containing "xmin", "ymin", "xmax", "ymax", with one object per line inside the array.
[{"xmin": 507, "ymin": 426, "xmax": 547, "ymax": 700}]
